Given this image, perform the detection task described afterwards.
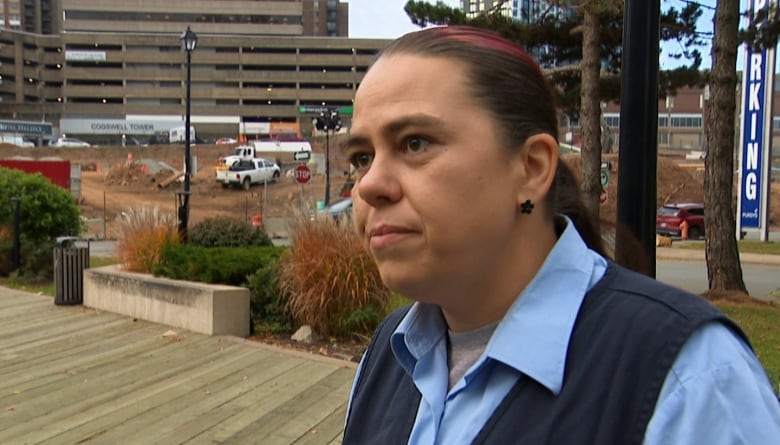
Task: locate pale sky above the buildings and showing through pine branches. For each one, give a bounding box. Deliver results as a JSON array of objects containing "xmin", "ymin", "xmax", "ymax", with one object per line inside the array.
[{"xmin": 346, "ymin": 0, "xmax": 724, "ymax": 69}]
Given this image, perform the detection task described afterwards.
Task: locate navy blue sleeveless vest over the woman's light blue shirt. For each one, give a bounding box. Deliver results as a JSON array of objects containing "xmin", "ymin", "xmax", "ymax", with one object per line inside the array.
[{"xmin": 342, "ymin": 263, "xmax": 747, "ymax": 445}]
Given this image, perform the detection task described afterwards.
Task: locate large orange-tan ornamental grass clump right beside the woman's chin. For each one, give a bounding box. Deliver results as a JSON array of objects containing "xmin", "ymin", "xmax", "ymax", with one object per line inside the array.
[{"xmin": 278, "ymin": 217, "xmax": 392, "ymax": 338}]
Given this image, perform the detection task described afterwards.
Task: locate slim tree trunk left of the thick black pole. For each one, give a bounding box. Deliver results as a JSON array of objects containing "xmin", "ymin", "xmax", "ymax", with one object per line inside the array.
[{"xmin": 580, "ymin": 7, "xmax": 601, "ymax": 225}]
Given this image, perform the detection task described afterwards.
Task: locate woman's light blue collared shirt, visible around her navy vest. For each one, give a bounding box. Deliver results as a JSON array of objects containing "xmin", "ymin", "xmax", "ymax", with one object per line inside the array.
[{"xmin": 350, "ymin": 221, "xmax": 780, "ymax": 445}]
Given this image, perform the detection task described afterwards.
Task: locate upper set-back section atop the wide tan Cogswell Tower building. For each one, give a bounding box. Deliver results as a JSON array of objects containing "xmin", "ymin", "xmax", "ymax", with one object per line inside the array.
[{"xmin": 16, "ymin": 0, "xmax": 349, "ymax": 37}]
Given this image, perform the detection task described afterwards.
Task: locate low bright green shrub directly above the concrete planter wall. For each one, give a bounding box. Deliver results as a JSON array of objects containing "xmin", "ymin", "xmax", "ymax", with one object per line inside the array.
[{"xmin": 152, "ymin": 244, "xmax": 283, "ymax": 286}]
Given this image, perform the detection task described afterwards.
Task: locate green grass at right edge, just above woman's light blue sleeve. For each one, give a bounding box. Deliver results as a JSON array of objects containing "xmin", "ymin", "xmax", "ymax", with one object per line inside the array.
[{"xmin": 715, "ymin": 302, "xmax": 780, "ymax": 392}]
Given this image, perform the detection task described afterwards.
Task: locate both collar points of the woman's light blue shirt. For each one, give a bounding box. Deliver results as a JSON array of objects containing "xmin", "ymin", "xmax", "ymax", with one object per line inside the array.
[{"xmin": 391, "ymin": 217, "xmax": 607, "ymax": 394}]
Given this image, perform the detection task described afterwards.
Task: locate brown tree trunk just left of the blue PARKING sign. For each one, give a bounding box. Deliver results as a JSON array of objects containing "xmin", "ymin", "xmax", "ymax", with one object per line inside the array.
[{"xmin": 704, "ymin": 0, "xmax": 746, "ymax": 292}]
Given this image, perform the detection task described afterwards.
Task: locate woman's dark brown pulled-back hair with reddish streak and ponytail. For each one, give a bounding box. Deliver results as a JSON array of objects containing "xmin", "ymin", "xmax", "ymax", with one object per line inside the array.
[{"xmin": 378, "ymin": 26, "xmax": 604, "ymax": 255}]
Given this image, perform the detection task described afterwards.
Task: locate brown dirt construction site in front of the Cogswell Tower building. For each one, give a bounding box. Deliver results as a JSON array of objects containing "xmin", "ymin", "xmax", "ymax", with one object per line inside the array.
[{"xmin": 0, "ymin": 140, "xmax": 780, "ymax": 239}]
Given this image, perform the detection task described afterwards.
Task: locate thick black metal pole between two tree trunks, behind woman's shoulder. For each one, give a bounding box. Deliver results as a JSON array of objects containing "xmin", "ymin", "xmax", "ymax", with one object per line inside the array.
[{"xmin": 615, "ymin": 0, "xmax": 660, "ymax": 277}]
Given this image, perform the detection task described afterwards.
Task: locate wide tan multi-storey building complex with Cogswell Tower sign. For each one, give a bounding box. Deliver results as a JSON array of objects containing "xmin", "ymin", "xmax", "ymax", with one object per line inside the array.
[{"xmin": 0, "ymin": 0, "xmax": 374, "ymax": 142}]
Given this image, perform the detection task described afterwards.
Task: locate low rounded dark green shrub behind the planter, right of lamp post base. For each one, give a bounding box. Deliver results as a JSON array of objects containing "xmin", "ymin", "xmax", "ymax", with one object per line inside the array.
[{"xmin": 187, "ymin": 216, "xmax": 273, "ymax": 247}]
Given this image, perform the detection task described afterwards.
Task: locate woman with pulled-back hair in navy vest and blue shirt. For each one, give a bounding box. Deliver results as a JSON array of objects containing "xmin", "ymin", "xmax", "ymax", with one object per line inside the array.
[{"xmin": 344, "ymin": 27, "xmax": 780, "ymax": 444}]
